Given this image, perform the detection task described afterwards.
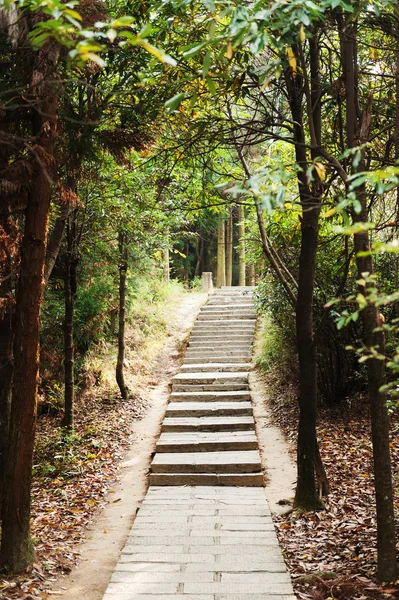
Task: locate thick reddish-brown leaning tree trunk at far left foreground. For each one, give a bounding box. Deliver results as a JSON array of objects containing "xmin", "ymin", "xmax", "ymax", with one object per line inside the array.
[{"xmin": 0, "ymin": 57, "xmax": 58, "ymax": 572}]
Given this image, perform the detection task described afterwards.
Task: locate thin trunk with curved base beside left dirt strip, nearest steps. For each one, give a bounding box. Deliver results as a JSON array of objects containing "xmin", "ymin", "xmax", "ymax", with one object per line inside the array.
[{"xmin": 116, "ymin": 233, "xmax": 129, "ymax": 400}]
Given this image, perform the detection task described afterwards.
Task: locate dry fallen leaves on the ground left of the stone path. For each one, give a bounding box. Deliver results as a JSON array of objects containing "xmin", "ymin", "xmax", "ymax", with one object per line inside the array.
[{"xmin": 0, "ymin": 396, "xmax": 146, "ymax": 600}]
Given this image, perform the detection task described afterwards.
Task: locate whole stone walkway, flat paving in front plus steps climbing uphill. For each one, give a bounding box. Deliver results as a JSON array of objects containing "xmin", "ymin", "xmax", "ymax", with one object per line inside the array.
[{"xmin": 103, "ymin": 287, "xmax": 295, "ymax": 600}]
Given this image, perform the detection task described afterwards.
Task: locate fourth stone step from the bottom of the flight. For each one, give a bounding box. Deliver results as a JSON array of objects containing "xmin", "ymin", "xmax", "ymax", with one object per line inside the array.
[{"xmin": 161, "ymin": 417, "xmax": 255, "ymax": 432}]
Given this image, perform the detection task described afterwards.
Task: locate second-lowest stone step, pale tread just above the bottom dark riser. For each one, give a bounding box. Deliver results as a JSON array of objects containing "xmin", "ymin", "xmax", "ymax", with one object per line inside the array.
[{"xmin": 151, "ymin": 450, "xmax": 261, "ymax": 473}]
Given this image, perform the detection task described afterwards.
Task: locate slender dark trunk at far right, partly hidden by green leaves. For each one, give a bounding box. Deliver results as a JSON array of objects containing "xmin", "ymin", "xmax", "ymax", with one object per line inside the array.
[{"xmin": 340, "ymin": 17, "xmax": 398, "ymax": 581}]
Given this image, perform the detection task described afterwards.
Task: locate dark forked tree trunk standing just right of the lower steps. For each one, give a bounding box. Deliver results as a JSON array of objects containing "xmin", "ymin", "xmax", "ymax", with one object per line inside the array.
[{"xmin": 286, "ymin": 44, "xmax": 323, "ymax": 510}]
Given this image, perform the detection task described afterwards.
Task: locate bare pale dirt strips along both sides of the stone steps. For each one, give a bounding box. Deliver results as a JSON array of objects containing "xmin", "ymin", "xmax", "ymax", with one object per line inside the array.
[{"xmin": 50, "ymin": 293, "xmax": 296, "ymax": 600}]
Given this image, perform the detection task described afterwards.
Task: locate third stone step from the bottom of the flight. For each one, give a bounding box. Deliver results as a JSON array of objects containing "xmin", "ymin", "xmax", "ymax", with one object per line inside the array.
[{"xmin": 156, "ymin": 431, "xmax": 258, "ymax": 452}]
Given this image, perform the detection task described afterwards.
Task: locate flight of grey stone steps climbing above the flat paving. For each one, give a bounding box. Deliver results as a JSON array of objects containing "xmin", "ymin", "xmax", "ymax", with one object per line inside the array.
[{"xmin": 150, "ymin": 287, "xmax": 263, "ymax": 486}]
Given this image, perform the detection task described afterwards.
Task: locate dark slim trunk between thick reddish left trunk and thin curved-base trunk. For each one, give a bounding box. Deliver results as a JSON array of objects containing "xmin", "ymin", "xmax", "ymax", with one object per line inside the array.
[{"xmin": 62, "ymin": 210, "xmax": 78, "ymax": 431}]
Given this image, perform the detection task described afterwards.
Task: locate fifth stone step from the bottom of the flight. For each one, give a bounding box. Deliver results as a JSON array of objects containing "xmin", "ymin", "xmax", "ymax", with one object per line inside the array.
[{"xmin": 165, "ymin": 400, "xmax": 252, "ymax": 417}]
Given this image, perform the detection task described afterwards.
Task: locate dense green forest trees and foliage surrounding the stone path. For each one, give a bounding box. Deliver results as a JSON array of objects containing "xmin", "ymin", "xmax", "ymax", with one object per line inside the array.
[{"xmin": 0, "ymin": 0, "xmax": 399, "ymax": 598}]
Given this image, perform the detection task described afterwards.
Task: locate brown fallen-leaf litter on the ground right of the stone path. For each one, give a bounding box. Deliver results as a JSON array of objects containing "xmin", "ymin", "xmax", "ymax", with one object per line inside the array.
[{"xmin": 271, "ymin": 399, "xmax": 399, "ymax": 600}]
